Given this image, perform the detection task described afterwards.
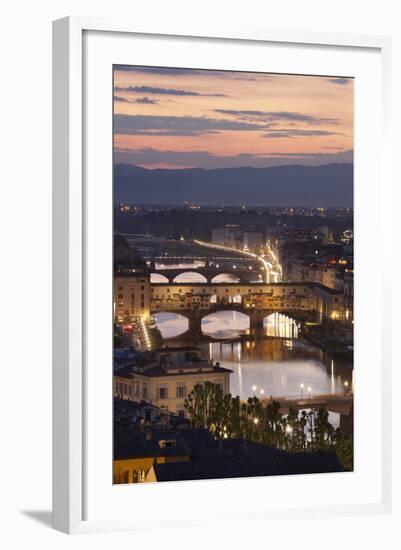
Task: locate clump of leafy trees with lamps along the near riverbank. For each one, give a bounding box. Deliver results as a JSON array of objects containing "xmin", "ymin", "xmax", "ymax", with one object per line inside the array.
[{"xmin": 184, "ymin": 382, "xmax": 353, "ymax": 470}]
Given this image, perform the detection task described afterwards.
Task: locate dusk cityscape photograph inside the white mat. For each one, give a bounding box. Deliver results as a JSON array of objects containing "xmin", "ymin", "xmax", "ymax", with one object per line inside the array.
[{"xmin": 110, "ymin": 65, "xmax": 355, "ymax": 484}]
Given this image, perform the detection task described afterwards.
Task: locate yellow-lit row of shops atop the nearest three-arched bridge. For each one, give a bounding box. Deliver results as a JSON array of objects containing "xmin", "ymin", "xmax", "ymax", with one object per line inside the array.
[{"xmin": 114, "ymin": 271, "xmax": 346, "ymax": 324}]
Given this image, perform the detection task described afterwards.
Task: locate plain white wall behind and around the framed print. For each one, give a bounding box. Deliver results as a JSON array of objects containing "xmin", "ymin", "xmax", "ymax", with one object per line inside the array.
[{"xmin": 0, "ymin": 0, "xmax": 401, "ymax": 550}]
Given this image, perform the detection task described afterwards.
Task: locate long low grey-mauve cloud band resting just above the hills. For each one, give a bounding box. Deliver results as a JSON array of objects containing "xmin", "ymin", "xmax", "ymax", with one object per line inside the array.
[{"xmin": 114, "ymin": 148, "xmax": 353, "ymax": 168}]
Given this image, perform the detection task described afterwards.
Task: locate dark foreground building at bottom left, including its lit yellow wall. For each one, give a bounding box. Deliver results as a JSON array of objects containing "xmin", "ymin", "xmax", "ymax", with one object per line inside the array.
[{"xmin": 114, "ymin": 404, "xmax": 344, "ymax": 483}]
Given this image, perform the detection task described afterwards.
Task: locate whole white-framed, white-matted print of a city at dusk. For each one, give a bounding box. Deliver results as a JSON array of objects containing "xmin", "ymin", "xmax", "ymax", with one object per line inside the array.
[{"xmin": 53, "ymin": 18, "xmax": 391, "ymax": 532}]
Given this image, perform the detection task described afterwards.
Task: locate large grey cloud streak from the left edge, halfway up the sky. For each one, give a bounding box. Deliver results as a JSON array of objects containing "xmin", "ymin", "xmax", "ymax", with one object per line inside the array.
[{"xmin": 114, "ymin": 114, "xmax": 270, "ymax": 136}]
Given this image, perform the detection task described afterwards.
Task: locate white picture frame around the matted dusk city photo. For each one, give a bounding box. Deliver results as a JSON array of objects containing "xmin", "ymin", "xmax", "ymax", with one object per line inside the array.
[{"xmin": 53, "ymin": 17, "xmax": 391, "ymax": 533}]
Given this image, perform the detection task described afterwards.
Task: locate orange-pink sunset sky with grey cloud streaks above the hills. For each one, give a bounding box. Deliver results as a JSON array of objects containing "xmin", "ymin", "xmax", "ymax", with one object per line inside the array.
[{"xmin": 113, "ymin": 65, "xmax": 354, "ymax": 169}]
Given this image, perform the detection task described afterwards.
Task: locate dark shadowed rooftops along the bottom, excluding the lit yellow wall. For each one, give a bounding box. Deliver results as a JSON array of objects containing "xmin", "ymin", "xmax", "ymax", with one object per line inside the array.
[{"xmin": 114, "ymin": 426, "xmax": 344, "ymax": 481}]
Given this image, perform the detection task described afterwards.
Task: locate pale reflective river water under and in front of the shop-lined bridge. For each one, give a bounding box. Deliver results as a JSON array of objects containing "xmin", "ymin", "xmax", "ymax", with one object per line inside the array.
[{"xmin": 155, "ymin": 311, "xmax": 352, "ymax": 420}]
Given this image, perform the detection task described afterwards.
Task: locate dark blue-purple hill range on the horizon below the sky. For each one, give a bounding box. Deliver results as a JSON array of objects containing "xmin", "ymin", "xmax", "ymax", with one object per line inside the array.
[{"xmin": 114, "ymin": 164, "xmax": 353, "ymax": 207}]
